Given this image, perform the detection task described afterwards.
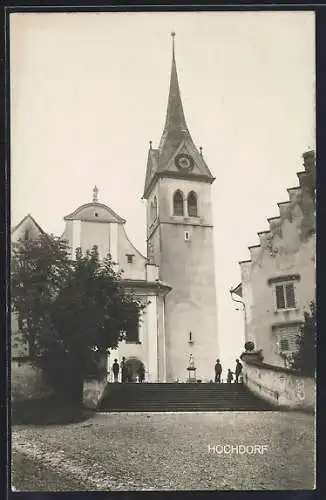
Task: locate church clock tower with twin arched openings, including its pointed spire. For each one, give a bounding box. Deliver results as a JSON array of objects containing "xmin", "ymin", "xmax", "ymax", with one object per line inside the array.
[{"xmin": 143, "ymin": 33, "xmax": 218, "ymax": 382}]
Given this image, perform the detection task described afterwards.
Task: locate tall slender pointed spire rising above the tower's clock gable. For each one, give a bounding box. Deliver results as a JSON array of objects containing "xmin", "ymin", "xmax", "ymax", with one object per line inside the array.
[{"xmin": 160, "ymin": 32, "xmax": 188, "ymax": 149}]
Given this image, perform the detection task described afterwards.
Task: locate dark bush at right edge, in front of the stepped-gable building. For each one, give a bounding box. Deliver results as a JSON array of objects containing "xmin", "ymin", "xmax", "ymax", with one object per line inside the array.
[{"xmin": 292, "ymin": 301, "xmax": 317, "ymax": 376}]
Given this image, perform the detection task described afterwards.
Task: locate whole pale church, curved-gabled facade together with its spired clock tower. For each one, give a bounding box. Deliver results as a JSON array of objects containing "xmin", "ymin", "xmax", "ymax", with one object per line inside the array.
[{"xmin": 12, "ymin": 33, "xmax": 218, "ymax": 382}]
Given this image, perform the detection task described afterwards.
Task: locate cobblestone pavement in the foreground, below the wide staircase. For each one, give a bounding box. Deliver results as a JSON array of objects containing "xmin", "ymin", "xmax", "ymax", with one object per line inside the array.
[{"xmin": 12, "ymin": 412, "xmax": 315, "ymax": 491}]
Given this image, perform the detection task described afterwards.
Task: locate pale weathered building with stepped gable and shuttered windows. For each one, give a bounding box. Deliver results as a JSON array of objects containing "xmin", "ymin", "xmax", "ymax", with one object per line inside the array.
[{"xmin": 231, "ymin": 151, "xmax": 316, "ymax": 367}]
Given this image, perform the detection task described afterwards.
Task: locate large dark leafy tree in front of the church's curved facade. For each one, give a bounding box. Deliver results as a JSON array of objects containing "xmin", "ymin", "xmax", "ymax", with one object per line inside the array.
[{"xmin": 12, "ymin": 235, "xmax": 144, "ymax": 399}]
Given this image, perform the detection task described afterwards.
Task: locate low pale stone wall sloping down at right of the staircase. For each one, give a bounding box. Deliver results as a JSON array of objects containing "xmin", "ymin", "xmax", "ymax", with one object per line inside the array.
[{"xmin": 242, "ymin": 358, "xmax": 316, "ymax": 412}]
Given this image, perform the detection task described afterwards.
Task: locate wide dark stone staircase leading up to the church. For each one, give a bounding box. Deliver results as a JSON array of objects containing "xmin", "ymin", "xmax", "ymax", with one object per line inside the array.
[{"xmin": 98, "ymin": 383, "xmax": 274, "ymax": 412}]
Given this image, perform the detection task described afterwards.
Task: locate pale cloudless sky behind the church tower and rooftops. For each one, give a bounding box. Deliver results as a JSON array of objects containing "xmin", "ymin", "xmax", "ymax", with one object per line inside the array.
[{"xmin": 10, "ymin": 11, "xmax": 315, "ymax": 374}]
